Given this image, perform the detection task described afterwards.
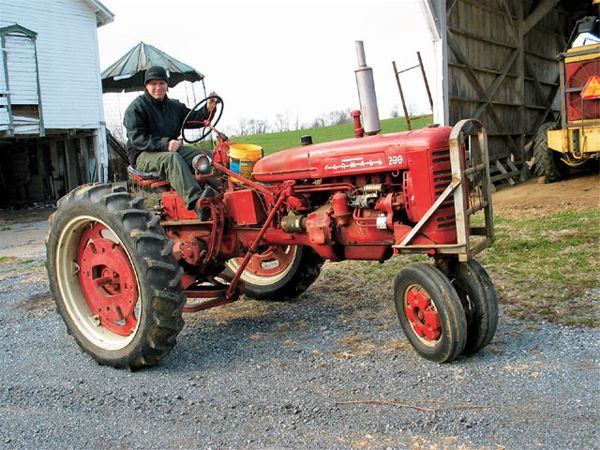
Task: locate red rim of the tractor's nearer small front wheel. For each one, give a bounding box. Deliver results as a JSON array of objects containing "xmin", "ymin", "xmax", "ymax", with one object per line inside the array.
[{"xmin": 404, "ymin": 286, "xmax": 442, "ymax": 343}]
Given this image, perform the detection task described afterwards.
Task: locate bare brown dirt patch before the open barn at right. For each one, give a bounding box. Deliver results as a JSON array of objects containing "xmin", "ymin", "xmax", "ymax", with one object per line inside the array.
[{"xmin": 493, "ymin": 173, "xmax": 600, "ymax": 218}]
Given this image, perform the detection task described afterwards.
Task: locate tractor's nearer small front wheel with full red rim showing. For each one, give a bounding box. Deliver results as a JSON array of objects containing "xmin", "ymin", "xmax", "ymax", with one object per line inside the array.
[{"xmin": 394, "ymin": 264, "xmax": 467, "ymax": 363}]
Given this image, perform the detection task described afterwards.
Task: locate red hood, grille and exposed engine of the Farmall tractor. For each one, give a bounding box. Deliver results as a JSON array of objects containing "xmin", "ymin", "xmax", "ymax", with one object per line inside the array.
[{"xmin": 253, "ymin": 127, "xmax": 456, "ymax": 260}]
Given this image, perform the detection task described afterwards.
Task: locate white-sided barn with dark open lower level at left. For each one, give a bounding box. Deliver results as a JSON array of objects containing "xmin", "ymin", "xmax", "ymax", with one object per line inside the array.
[{"xmin": 0, "ymin": 0, "xmax": 113, "ymax": 207}]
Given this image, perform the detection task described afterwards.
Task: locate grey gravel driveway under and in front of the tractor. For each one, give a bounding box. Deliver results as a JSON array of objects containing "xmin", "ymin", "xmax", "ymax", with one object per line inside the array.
[{"xmin": 0, "ymin": 223, "xmax": 600, "ymax": 449}]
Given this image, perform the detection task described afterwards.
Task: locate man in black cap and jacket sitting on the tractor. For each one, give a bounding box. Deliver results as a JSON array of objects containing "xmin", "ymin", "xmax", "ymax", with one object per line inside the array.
[{"xmin": 123, "ymin": 66, "xmax": 217, "ymax": 220}]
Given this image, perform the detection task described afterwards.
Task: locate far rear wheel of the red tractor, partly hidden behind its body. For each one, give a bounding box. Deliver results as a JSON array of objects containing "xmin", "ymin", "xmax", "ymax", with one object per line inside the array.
[{"xmin": 226, "ymin": 245, "xmax": 323, "ymax": 301}]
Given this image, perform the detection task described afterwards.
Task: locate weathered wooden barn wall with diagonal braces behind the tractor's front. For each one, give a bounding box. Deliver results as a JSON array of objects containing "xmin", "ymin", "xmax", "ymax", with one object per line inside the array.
[{"xmin": 447, "ymin": 0, "xmax": 565, "ymax": 161}]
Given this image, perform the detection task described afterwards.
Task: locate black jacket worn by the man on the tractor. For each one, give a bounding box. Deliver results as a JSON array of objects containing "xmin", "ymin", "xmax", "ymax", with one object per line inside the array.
[{"xmin": 123, "ymin": 92, "xmax": 208, "ymax": 167}]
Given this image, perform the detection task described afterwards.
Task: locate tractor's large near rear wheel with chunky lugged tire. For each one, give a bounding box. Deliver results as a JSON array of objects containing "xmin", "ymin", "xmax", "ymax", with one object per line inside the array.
[{"xmin": 46, "ymin": 184, "xmax": 186, "ymax": 369}]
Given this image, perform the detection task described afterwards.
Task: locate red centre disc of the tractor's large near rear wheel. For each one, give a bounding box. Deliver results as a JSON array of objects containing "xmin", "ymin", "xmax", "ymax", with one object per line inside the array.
[{"xmin": 77, "ymin": 222, "xmax": 138, "ymax": 336}]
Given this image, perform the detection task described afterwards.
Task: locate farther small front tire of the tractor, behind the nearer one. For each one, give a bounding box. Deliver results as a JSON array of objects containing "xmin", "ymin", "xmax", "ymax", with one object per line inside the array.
[{"xmin": 449, "ymin": 259, "xmax": 498, "ymax": 355}]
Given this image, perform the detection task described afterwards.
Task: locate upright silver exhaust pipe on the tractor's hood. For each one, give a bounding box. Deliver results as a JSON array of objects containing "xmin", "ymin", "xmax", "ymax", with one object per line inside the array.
[{"xmin": 354, "ymin": 41, "xmax": 381, "ymax": 135}]
